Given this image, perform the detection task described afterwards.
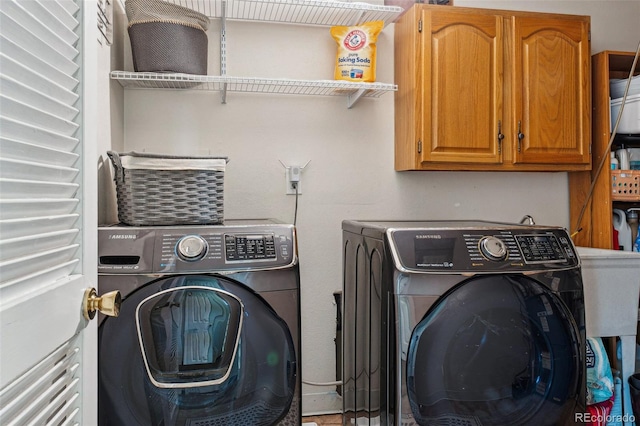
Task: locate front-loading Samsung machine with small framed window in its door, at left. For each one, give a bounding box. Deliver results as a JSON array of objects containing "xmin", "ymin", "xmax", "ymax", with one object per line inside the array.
[{"xmin": 98, "ymin": 220, "xmax": 301, "ymax": 426}]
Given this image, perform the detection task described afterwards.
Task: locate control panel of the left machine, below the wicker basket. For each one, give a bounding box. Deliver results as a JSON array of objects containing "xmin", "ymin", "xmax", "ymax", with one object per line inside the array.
[{"xmin": 98, "ymin": 224, "xmax": 297, "ymax": 274}]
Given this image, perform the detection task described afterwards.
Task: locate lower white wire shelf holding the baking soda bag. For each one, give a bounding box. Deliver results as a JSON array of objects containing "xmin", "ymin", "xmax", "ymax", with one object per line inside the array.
[{"xmin": 111, "ymin": 71, "xmax": 398, "ymax": 107}]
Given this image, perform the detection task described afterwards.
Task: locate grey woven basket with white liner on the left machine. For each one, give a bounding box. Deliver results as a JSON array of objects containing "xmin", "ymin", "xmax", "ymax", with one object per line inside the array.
[{"xmin": 107, "ymin": 151, "xmax": 227, "ymax": 226}]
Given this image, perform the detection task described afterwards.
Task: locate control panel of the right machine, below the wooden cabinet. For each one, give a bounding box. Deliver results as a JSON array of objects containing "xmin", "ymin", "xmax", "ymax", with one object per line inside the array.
[{"xmin": 387, "ymin": 226, "xmax": 578, "ymax": 273}]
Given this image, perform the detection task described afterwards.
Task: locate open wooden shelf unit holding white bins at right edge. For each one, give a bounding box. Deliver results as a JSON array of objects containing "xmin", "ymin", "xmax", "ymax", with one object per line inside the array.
[{"xmin": 569, "ymin": 51, "xmax": 640, "ymax": 249}]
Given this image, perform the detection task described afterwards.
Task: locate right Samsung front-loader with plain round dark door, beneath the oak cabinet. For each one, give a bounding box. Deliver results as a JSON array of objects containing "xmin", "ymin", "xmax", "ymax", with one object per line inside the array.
[{"xmin": 342, "ymin": 221, "xmax": 586, "ymax": 426}]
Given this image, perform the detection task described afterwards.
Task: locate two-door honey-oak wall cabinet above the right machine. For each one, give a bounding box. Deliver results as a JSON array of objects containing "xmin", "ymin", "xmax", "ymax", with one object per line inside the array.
[{"xmin": 395, "ymin": 4, "xmax": 591, "ymax": 171}]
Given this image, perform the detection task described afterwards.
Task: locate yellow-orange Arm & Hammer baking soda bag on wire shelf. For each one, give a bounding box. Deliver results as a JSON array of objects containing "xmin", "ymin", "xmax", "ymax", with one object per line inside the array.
[{"xmin": 331, "ymin": 21, "xmax": 384, "ymax": 83}]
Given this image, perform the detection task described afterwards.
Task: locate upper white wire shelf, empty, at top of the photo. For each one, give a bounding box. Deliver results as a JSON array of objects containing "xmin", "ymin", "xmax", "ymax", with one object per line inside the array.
[{"xmin": 166, "ymin": 0, "xmax": 403, "ymax": 26}]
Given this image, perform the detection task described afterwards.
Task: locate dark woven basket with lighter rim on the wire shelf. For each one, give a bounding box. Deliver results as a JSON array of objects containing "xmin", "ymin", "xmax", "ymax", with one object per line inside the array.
[{"xmin": 125, "ymin": 0, "xmax": 209, "ymax": 75}]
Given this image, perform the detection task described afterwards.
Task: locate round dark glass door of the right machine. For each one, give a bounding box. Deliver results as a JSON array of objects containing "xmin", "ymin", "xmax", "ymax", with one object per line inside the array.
[{"xmin": 406, "ymin": 275, "xmax": 584, "ymax": 426}]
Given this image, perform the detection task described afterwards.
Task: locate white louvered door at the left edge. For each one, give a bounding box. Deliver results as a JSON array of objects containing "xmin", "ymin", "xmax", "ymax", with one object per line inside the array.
[{"xmin": 0, "ymin": 0, "xmax": 99, "ymax": 426}]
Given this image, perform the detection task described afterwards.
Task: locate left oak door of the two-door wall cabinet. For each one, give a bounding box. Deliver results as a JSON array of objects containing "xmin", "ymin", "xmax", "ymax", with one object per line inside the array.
[{"xmin": 420, "ymin": 9, "xmax": 504, "ymax": 164}]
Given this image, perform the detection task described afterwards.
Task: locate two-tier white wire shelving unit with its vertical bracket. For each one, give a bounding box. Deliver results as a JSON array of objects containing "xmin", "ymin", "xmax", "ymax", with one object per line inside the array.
[{"xmin": 111, "ymin": 0, "xmax": 403, "ymax": 108}]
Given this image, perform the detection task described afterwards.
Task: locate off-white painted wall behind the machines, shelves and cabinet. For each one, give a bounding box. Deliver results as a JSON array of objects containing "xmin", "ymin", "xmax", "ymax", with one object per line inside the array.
[{"xmin": 102, "ymin": 0, "xmax": 640, "ymax": 414}]
